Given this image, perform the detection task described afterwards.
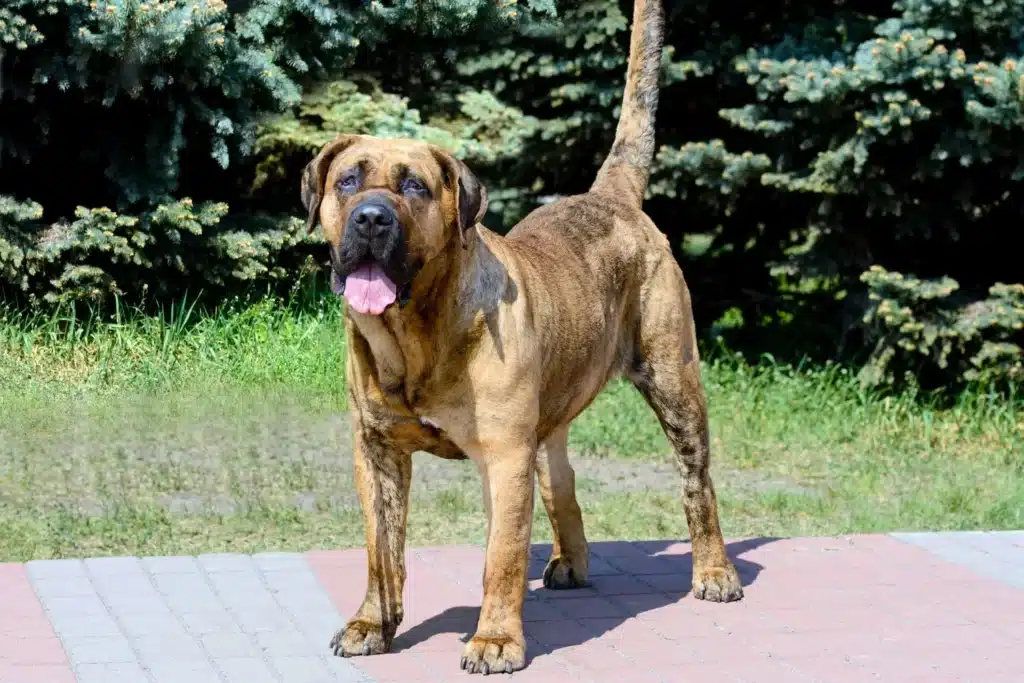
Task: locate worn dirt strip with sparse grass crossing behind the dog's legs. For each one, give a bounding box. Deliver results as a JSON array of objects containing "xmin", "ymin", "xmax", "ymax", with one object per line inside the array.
[{"xmin": 0, "ymin": 387, "xmax": 815, "ymax": 516}]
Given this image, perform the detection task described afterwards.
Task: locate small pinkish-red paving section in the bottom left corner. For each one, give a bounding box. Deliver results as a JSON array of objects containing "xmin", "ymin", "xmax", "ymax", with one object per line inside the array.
[{"xmin": 0, "ymin": 564, "xmax": 75, "ymax": 683}]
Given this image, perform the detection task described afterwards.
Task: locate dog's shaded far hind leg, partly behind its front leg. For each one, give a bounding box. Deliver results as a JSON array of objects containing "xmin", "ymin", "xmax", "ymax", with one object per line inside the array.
[{"xmin": 537, "ymin": 425, "xmax": 590, "ymax": 589}]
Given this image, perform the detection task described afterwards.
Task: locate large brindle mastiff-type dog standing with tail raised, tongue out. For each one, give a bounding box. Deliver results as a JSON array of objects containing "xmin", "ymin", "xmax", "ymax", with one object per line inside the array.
[{"xmin": 301, "ymin": 0, "xmax": 742, "ymax": 674}]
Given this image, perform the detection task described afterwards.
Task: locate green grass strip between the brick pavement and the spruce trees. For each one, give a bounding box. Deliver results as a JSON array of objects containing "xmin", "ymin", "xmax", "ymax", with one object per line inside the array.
[{"xmin": 0, "ymin": 300, "xmax": 1024, "ymax": 561}]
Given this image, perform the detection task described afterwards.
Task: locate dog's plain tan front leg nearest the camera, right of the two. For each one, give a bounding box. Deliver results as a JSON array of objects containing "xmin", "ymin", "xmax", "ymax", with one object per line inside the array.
[{"xmin": 462, "ymin": 447, "xmax": 536, "ymax": 674}]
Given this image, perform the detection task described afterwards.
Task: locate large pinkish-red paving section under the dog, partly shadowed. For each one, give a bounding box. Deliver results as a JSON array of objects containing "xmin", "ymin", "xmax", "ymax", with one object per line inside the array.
[{"xmin": 306, "ymin": 536, "xmax": 1024, "ymax": 683}]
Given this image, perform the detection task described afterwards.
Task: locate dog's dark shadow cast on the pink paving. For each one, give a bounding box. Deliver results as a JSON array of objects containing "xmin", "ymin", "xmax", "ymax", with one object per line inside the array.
[{"xmin": 391, "ymin": 538, "xmax": 776, "ymax": 659}]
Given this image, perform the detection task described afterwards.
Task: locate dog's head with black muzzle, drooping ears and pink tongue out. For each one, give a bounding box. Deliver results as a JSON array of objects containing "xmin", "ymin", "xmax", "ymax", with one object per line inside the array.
[{"xmin": 302, "ymin": 135, "xmax": 487, "ymax": 315}]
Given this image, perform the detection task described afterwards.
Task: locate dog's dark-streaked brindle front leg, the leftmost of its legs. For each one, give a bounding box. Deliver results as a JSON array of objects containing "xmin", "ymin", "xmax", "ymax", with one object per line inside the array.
[{"xmin": 331, "ymin": 429, "xmax": 413, "ymax": 656}]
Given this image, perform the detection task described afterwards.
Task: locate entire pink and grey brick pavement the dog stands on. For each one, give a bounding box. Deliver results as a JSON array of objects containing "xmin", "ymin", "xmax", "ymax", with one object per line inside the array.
[{"xmin": 0, "ymin": 531, "xmax": 1024, "ymax": 683}]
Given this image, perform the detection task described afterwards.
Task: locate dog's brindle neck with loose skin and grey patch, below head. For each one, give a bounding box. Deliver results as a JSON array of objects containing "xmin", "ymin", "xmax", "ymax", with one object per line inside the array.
[{"xmin": 348, "ymin": 228, "xmax": 514, "ymax": 410}]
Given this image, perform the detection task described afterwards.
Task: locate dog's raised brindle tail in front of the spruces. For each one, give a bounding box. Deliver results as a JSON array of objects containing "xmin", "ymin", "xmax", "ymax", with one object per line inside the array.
[{"xmin": 590, "ymin": 0, "xmax": 665, "ymax": 207}]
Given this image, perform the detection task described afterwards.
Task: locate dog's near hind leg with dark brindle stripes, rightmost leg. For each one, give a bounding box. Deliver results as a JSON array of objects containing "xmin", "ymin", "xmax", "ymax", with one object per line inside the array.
[{"xmin": 629, "ymin": 256, "xmax": 743, "ymax": 602}]
